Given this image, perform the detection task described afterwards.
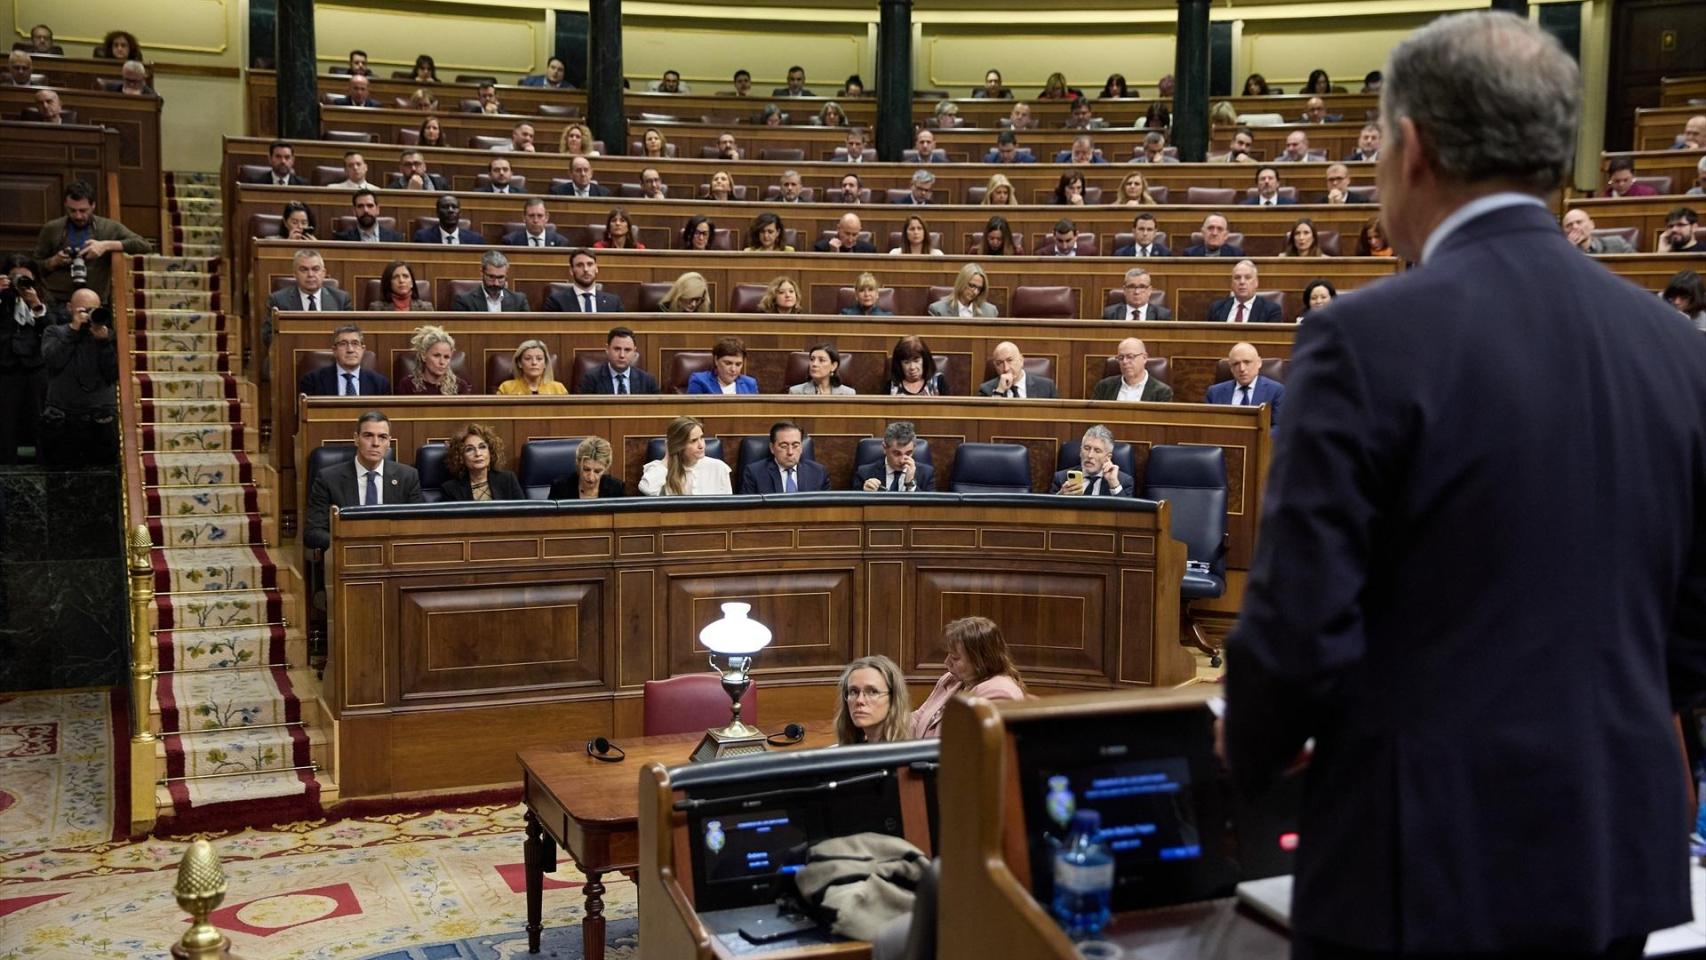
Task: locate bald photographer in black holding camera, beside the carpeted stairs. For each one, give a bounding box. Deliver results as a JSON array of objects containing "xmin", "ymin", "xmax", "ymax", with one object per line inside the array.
[{"xmin": 38, "ymin": 288, "xmax": 118, "ymax": 467}]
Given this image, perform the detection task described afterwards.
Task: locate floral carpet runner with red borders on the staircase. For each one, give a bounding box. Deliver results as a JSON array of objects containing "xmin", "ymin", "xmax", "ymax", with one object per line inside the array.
[{"xmin": 130, "ymin": 172, "xmax": 336, "ymax": 830}]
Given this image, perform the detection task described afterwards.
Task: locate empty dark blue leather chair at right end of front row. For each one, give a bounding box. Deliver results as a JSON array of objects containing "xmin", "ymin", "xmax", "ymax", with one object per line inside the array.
[{"xmin": 1143, "ymin": 443, "xmax": 1227, "ymax": 667}]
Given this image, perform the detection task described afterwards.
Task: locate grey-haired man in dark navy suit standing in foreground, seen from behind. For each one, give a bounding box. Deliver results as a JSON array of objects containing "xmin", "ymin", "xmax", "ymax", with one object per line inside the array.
[{"xmin": 1225, "ymin": 12, "xmax": 1706, "ymax": 958}]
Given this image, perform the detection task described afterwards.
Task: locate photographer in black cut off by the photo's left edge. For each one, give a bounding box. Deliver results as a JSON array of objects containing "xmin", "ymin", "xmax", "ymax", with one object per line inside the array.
[{"xmin": 0, "ymin": 254, "xmax": 56, "ymax": 464}]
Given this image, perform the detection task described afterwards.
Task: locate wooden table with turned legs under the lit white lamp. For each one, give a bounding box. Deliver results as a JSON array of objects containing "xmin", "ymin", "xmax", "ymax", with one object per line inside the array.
[{"xmin": 517, "ymin": 720, "xmax": 834, "ymax": 960}]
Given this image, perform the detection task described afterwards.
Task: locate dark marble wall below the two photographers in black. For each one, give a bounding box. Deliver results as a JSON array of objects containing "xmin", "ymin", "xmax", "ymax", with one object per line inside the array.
[{"xmin": 0, "ymin": 467, "xmax": 130, "ymax": 692}]
